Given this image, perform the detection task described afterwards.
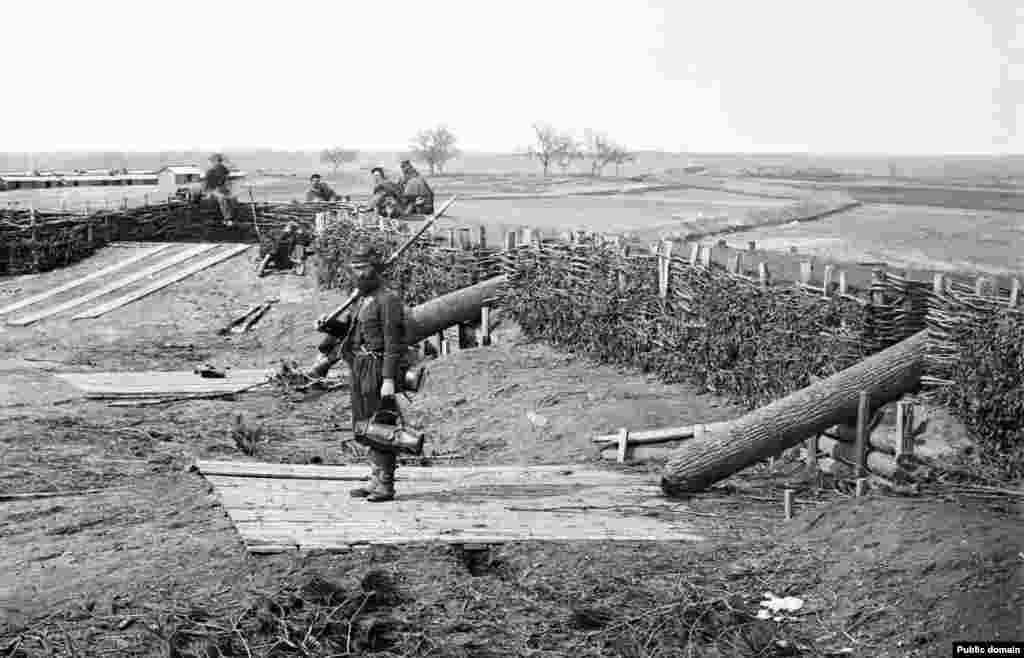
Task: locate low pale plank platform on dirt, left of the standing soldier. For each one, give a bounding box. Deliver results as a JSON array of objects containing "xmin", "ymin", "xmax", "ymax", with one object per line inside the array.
[{"xmin": 55, "ymin": 369, "xmax": 272, "ymax": 398}]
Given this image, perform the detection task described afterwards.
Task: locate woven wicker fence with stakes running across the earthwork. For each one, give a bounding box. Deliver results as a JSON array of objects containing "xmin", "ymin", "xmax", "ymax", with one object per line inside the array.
[{"xmin": 0, "ymin": 201, "xmax": 1024, "ymax": 476}]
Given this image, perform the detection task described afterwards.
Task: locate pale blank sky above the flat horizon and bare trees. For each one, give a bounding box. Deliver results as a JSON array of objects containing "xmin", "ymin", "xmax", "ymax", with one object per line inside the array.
[{"xmin": 0, "ymin": 0, "xmax": 1024, "ymax": 155}]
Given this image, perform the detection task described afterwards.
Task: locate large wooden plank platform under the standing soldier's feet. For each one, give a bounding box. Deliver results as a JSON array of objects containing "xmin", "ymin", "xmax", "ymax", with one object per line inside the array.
[{"xmin": 196, "ymin": 462, "xmax": 703, "ymax": 553}]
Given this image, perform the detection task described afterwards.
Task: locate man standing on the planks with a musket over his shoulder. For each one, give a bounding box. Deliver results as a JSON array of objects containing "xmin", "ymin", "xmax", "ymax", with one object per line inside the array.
[{"xmin": 330, "ymin": 246, "xmax": 406, "ymax": 502}]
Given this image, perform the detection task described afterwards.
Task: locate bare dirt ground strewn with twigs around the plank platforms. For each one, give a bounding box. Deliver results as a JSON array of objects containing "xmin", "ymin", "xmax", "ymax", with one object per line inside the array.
[{"xmin": 0, "ymin": 247, "xmax": 1024, "ymax": 656}]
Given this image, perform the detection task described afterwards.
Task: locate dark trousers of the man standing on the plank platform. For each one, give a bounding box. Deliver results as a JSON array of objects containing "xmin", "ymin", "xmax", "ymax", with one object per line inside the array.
[{"xmin": 348, "ymin": 353, "xmax": 398, "ymax": 493}]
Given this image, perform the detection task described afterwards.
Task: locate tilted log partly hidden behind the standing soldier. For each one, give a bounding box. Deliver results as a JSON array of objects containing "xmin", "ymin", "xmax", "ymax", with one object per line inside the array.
[{"xmin": 308, "ymin": 274, "xmax": 508, "ymax": 378}]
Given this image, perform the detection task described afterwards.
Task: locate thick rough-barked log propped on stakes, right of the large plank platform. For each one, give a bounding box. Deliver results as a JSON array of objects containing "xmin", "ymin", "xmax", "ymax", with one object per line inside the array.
[{"xmin": 662, "ymin": 332, "xmax": 928, "ymax": 496}]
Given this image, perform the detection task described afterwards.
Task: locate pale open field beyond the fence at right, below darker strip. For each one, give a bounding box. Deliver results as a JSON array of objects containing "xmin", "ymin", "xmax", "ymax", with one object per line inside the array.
[{"xmin": 711, "ymin": 204, "xmax": 1024, "ymax": 274}]
